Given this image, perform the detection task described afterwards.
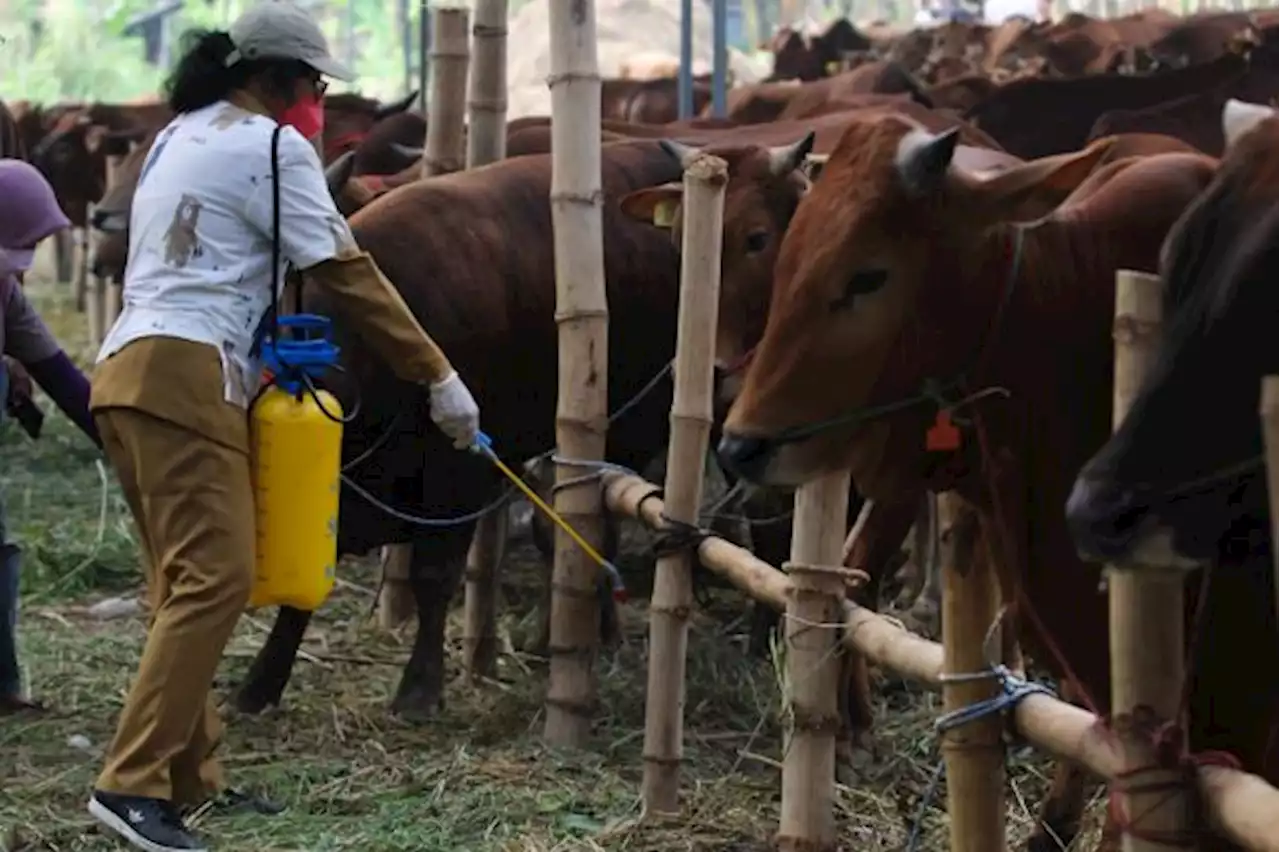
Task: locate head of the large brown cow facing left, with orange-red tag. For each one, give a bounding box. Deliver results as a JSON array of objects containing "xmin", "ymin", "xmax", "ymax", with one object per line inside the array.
[{"xmin": 721, "ymin": 116, "xmax": 1111, "ymax": 499}]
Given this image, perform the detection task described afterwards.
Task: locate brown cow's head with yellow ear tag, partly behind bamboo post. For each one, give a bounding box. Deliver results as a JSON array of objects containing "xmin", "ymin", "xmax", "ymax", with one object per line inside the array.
[{"xmin": 621, "ymin": 133, "xmax": 814, "ymax": 406}]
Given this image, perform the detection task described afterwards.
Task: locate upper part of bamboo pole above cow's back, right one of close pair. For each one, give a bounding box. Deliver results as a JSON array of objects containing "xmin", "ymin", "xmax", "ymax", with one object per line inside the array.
[{"xmin": 467, "ymin": 0, "xmax": 507, "ymax": 169}]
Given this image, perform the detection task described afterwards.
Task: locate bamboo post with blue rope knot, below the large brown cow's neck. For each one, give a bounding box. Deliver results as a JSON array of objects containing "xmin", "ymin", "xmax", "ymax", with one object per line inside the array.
[{"xmin": 941, "ymin": 493, "xmax": 1005, "ymax": 852}]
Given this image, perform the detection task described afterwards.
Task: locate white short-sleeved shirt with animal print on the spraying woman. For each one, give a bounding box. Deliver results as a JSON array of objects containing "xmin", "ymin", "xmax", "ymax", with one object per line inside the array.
[{"xmin": 97, "ymin": 101, "xmax": 355, "ymax": 406}]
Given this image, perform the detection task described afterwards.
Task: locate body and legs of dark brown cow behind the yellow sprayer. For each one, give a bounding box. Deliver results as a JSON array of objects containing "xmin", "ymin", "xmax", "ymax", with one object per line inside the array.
[{"xmin": 238, "ymin": 142, "xmax": 824, "ymax": 718}]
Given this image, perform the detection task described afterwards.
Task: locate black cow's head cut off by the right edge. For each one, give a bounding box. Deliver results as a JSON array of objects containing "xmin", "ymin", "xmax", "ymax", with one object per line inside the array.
[{"xmin": 1066, "ymin": 100, "xmax": 1280, "ymax": 564}]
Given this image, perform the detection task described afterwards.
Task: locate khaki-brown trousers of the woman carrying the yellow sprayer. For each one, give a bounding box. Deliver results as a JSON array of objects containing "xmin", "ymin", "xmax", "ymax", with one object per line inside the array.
[{"xmin": 95, "ymin": 408, "xmax": 255, "ymax": 805}]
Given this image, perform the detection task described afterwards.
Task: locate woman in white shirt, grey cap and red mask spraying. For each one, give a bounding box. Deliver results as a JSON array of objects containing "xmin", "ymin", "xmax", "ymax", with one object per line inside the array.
[{"xmin": 88, "ymin": 0, "xmax": 479, "ymax": 852}]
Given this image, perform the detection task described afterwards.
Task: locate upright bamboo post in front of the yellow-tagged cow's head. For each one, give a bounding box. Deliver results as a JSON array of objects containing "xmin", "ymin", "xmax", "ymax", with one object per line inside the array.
[{"xmin": 643, "ymin": 154, "xmax": 728, "ymax": 814}]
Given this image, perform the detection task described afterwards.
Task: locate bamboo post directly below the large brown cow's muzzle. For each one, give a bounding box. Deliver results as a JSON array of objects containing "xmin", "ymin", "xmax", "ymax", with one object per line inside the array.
[{"xmin": 777, "ymin": 472, "xmax": 849, "ymax": 852}]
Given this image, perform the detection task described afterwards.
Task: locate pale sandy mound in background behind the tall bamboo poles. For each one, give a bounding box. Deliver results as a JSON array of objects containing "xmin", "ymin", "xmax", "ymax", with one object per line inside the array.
[{"xmin": 507, "ymin": 0, "xmax": 768, "ymax": 119}]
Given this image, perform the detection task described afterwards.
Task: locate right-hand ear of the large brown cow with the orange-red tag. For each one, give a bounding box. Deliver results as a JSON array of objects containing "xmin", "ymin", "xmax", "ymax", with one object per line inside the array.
[{"xmin": 966, "ymin": 136, "xmax": 1116, "ymax": 221}]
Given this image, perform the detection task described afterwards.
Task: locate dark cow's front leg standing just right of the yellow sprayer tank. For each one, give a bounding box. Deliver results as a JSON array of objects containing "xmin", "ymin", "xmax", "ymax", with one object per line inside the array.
[{"xmin": 390, "ymin": 534, "xmax": 474, "ymax": 722}]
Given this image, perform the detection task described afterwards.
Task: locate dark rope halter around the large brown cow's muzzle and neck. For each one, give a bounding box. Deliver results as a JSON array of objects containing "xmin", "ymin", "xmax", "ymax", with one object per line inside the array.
[{"xmin": 769, "ymin": 225, "xmax": 1025, "ymax": 446}]
